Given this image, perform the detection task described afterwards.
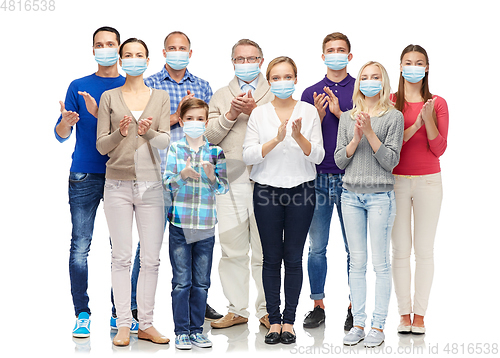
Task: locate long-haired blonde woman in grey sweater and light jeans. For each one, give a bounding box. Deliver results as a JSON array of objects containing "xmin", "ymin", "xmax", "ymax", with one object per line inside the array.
[{"xmin": 334, "ymin": 62, "xmax": 404, "ymax": 347}]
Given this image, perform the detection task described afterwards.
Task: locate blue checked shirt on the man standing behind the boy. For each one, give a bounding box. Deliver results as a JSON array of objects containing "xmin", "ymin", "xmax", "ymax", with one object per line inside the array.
[{"xmin": 144, "ymin": 66, "xmax": 212, "ymax": 173}]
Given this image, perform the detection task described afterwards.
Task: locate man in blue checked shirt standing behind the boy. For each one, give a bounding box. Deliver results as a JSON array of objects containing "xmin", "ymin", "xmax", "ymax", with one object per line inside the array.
[{"xmin": 143, "ymin": 31, "xmax": 222, "ymax": 320}]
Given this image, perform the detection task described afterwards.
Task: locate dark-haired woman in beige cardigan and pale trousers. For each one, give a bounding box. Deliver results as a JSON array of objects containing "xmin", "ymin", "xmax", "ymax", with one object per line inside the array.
[{"xmin": 97, "ymin": 38, "xmax": 170, "ymax": 346}]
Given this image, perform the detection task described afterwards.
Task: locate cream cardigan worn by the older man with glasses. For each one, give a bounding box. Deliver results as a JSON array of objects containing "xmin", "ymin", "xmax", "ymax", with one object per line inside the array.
[{"xmin": 205, "ymin": 73, "xmax": 274, "ymax": 183}]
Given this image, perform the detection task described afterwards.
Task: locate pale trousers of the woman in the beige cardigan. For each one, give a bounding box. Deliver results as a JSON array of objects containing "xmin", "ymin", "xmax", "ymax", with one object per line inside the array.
[{"xmin": 104, "ymin": 179, "xmax": 165, "ymax": 330}]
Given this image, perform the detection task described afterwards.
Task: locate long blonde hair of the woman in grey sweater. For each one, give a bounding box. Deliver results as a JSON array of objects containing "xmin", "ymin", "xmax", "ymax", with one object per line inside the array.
[{"xmin": 351, "ymin": 61, "xmax": 394, "ymax": 119}]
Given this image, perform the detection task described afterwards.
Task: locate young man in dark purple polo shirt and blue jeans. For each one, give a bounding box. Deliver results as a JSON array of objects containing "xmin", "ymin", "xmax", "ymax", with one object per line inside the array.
[{"xmin": 302, "ymin": 32, "xmax": 355, "ymax": 331}]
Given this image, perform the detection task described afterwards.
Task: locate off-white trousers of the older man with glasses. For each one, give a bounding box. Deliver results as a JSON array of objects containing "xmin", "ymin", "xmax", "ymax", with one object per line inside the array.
[{"xmin": 217, "ymin": 182, "xmax": 267, "ymax": 318}]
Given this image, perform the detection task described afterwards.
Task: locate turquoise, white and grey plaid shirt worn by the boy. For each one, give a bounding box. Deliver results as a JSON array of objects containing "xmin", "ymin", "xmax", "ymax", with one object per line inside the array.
[{"xmin": 163, "ymin": 137, "xmax": 229, "ymax": 229}]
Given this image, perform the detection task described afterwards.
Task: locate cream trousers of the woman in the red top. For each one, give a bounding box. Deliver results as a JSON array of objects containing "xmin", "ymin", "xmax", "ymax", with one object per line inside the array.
[{"xmin": 392, "ymin": 173, "xmax": 443, "ymax": 316}]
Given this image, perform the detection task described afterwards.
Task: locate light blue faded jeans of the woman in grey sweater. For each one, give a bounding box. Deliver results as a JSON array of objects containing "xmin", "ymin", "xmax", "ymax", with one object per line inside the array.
[{"xmin": 342, "ymin": 189, "xmax": 396, "ymax": 329}]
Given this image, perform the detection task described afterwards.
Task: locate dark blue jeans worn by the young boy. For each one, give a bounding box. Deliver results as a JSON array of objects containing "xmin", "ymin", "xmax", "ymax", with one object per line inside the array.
[{"xmin": 169, "ymin": 224, "xmax": 215, "ymax": 335}]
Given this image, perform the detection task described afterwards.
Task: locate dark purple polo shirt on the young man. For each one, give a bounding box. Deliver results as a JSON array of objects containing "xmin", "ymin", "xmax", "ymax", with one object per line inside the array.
[{"xmin": 301, "ymin": 74, "xmax": 356, "ymax": 174}]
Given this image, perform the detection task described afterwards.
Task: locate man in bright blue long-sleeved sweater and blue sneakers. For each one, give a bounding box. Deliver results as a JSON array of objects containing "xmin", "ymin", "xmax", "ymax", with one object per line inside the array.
[{"xmin": 54, "ymin": 27, "xmax": 125, "ymax": 337}]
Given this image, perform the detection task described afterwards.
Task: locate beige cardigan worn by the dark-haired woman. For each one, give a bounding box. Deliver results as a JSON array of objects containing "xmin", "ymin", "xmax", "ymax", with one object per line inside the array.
[{"xmin": 97, "ymin": 87, "xmax": 170, "ymax": 181}]
